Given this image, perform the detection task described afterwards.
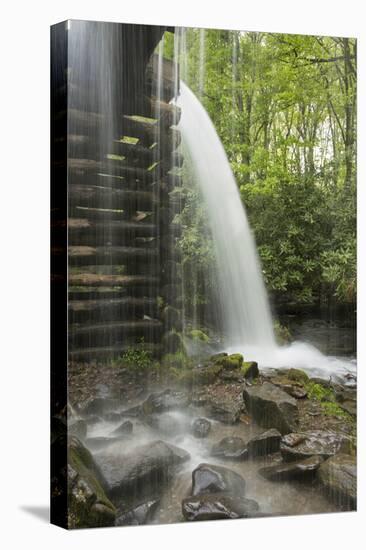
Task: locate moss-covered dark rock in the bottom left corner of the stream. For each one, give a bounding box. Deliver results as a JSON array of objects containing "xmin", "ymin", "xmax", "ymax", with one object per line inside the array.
[{"xmin": 68, "ymin": 437, "xmax": 116, "ymax": 528}]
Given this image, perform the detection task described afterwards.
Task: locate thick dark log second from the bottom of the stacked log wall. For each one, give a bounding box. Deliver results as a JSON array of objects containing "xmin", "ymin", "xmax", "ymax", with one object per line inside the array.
[{"xmin": 69, "ymin": 320, "xmax": 162, "ymax": 348}]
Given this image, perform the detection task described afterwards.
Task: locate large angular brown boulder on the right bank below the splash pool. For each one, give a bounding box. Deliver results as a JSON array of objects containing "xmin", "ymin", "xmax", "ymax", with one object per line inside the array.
[{"xmin": 243, "ymin": 382, "xmax": 299, "ymax": 434}]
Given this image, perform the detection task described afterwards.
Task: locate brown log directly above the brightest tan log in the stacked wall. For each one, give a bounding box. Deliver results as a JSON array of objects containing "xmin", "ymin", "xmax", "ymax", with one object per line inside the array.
[{"xmin": 68, "ymin": 246, "xmax": 158, "ymax": 266}]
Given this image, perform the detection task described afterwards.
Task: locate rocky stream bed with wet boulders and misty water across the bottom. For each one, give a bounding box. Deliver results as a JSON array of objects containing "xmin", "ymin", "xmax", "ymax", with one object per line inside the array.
[{"xmin": 53, "ymin": 354, "xmax": 356, "ymax": 528}]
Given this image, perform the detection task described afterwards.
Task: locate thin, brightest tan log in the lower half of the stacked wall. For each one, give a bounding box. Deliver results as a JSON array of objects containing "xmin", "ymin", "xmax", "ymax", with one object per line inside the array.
[{"xmin": 69, "ymin": 273, "xmax": 159, "ymax": 287}]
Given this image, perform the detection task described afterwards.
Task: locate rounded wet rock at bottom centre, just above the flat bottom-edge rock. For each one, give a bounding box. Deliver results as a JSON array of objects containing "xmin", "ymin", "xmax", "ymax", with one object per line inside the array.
[{"xmin": 192, "ymin": 464, "xmax": 245, "ymax": 496}]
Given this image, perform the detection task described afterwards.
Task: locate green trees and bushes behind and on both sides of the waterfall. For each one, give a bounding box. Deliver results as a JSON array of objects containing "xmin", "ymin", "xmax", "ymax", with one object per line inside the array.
[{"xmin": 179, "ymin": 29, "xmax": 356, "ymax": 310}]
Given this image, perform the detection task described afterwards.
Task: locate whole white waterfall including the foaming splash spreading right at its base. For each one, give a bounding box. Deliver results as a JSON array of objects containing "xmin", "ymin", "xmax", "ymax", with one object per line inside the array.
[{"xmin": 177, "ymin": 81, "xmax": 356, "ymax": 384}]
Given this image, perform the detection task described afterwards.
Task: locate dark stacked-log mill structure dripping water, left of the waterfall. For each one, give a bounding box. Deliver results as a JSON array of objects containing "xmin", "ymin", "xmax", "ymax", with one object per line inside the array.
[{"xmin": 51, "ymin": 21, "xmax": 183, "ymax": 370}]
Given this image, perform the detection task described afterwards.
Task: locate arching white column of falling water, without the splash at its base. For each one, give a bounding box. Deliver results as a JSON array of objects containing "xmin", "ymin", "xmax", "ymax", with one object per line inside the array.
[{"xmin": 177, "ymin": 82, "xmax": 275, "ymax": 347}]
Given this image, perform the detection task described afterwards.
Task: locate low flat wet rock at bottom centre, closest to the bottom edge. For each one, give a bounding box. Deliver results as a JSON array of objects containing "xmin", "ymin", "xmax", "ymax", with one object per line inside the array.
[{"xmin": 182, "ymin": 493, "xmax": 259, "ymax": 521}]
